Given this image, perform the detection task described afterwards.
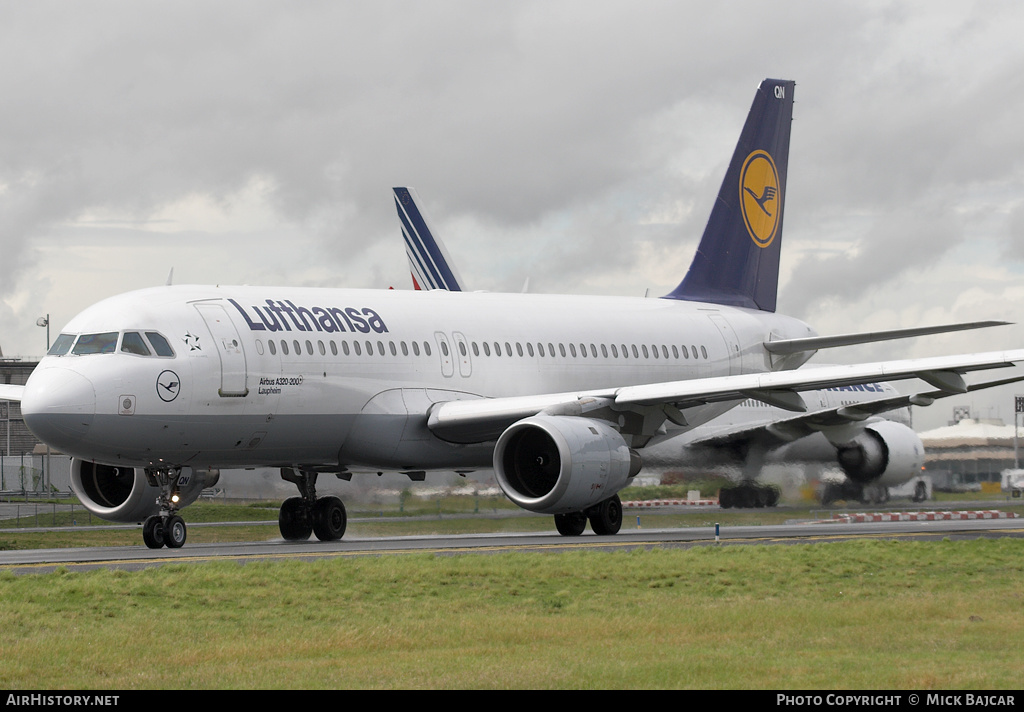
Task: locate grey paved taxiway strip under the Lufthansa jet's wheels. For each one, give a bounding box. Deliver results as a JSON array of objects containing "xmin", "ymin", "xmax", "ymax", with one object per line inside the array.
[{"xmin": 0, "ymin": 510, "xmax": 1024, "ymax": 574}]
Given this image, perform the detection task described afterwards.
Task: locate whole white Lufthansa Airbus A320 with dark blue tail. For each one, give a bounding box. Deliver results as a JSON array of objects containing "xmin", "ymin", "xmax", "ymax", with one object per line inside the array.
[{"xmin": 0, "ymin": 79, "xmax": 1024, "ymax": 547}]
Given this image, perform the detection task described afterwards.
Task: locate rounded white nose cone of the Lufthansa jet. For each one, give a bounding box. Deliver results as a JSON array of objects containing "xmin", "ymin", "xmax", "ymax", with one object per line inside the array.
[{"xmin": 22, "ymin": 368, "xmax": 96, "ymax": 453}]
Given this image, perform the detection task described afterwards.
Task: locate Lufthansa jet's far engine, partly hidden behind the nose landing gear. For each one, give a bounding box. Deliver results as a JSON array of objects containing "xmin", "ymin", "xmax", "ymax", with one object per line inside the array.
[{"xmin": 71, "ymin": 457, "xmax": 220, "ymax": 521}]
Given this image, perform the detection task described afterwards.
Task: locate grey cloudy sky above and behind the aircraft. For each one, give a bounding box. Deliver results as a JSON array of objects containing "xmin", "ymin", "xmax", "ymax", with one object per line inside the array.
[{"xmin": 0, "ymin": 0, "xmax": 1024, "ymax": 422}]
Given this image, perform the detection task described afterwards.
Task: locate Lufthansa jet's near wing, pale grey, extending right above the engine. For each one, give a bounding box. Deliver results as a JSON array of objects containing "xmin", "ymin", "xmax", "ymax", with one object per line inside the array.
[{"xmin": 427, "ymin": 350, "xmax": 1024, "ymax": 443}]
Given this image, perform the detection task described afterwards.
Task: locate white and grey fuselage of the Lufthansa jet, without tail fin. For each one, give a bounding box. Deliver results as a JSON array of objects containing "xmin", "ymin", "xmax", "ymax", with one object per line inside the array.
[{"xmin": 22, "ymin": 286, "xmax": 812, "ymax": 469}]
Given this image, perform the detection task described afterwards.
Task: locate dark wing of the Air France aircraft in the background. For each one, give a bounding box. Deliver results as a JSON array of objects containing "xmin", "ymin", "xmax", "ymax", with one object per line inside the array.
[{"xmin": 687, "ymin": 376, "xmax": 1024, "ymax": 449}]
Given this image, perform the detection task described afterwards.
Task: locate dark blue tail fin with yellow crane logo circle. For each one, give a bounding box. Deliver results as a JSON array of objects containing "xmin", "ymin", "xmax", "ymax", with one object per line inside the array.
[{"xmin": 665, "ymin": 79, "xmax": 796, "ymax": 311}]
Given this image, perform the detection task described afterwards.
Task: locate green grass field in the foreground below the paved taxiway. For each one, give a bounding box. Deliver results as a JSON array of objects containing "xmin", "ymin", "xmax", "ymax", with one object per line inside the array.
[{"xmin": 0, "ymin": 539, "xmax": 1024, "ymax": 690}]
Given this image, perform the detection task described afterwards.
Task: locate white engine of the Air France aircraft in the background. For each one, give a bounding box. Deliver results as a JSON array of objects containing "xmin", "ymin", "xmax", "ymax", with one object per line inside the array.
[{"xmin": 837, "ymin": 420, "xmax": 925, "ymax": 487}]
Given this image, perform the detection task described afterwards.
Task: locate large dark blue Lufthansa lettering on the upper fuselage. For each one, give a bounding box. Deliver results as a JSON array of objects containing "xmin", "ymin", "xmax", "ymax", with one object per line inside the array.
[{"xmin": 227, "ymin": 299, "xmax": 388, "ymax": 334}]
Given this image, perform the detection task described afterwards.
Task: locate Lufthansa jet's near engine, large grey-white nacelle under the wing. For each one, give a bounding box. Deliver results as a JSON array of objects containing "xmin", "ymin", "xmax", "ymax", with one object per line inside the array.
[{"xmin": 495, "ymin": 415, "xmax": 641, "ymax": 514}]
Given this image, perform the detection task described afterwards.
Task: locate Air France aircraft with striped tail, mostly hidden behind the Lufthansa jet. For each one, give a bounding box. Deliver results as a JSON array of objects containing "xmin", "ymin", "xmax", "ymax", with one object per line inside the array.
[{"xmin": 392, "ymin": 187, "xmax": 1024, "ymax": 508}]
